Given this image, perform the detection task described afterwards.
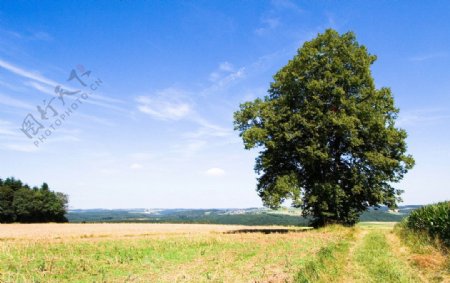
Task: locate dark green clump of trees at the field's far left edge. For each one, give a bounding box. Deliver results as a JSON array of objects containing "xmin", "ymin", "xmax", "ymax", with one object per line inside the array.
[{"xmin": 0, "ymin": 178, "xmax": 68, "ymax": 223}]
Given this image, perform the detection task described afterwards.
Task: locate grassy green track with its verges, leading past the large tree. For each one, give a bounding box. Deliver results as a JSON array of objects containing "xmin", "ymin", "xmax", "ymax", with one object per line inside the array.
[{"xmin": 296, "ymin": 227, "xmax": 428, "ymax": 283}]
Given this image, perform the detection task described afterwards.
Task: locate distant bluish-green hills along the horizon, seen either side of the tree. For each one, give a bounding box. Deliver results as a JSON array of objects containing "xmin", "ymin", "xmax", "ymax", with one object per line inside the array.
[{"xmin": 67, "ymin": 205, "xmax": 421, "ymax": 226}]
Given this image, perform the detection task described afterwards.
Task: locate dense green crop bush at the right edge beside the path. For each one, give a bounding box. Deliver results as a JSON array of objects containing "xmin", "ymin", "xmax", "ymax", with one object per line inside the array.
[{"xmin": 405, "ymin": 201, "xmax": 450, "ymax": 247}]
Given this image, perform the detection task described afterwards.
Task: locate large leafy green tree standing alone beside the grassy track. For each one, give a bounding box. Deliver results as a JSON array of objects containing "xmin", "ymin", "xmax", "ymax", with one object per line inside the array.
[{"xmin": 234, "ymin": 29, "xmax": 414, "ymax": 229}]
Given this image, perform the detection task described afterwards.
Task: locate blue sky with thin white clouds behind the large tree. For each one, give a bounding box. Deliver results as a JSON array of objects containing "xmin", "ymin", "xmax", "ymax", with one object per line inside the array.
[{"xmin": 0, "ymin": 0, "xmax": 450, "ymax": 208}]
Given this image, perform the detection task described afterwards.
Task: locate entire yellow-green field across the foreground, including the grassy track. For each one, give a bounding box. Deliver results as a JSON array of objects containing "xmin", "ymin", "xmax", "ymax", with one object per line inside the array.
[{"xmin": 0, "ymin": 223, "xmax": 448, "ymax": 282}]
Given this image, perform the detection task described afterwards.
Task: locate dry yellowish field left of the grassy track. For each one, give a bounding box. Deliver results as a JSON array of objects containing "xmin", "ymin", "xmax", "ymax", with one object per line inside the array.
[{"xmin": 0, "ymin": 224, "xmax": 334, "ymax": 282}]
